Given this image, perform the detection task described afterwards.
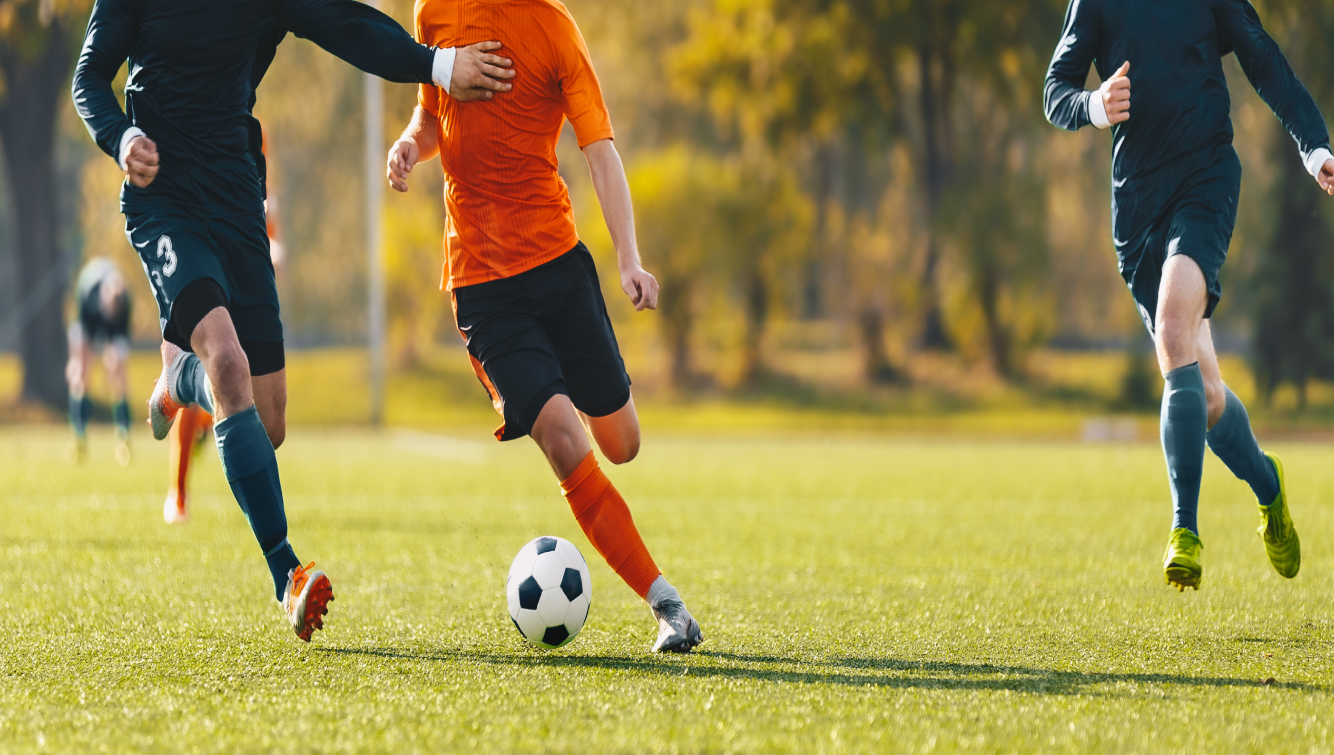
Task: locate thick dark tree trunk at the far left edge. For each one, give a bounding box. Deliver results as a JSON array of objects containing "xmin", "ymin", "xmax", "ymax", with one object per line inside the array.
[{"xmin": 0, "ymin": 21, "xmax": 72, "ymax": 407}]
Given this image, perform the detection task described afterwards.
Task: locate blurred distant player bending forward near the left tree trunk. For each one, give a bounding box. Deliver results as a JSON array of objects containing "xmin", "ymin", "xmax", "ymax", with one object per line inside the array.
[{"xmin": 65, "ymin": 257, "xmax": 129, "ymax": 467}]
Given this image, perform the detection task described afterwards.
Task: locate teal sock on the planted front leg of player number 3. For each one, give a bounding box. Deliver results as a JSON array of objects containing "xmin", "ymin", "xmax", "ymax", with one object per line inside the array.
[{"xmin": 213, "ymin": 406, "xmax": 301, "ymax": 600}]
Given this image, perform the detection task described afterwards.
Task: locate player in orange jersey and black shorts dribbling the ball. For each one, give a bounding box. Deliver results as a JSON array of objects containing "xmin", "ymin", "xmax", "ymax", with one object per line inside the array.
[{"xmin": 388, "ymin": 0, "xmax": 703, "ymax": 652}]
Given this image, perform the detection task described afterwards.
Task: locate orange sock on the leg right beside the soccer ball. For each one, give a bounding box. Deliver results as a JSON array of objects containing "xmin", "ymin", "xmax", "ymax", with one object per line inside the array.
[{"xmin": 560, "ymin": 451, "xmax": 662, "ymax": 598}]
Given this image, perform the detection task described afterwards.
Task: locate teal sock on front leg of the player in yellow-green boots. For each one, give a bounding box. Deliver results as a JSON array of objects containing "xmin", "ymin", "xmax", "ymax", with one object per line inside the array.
[{"xmin": 1161, "ymin": 361, "xmax": 1209, "ymax": 535}]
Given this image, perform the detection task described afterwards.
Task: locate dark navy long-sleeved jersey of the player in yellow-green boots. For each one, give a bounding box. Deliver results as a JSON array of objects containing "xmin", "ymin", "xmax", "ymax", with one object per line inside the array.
[{"xmin": 1043, "ymin": 0, "xmax": 1330, "ymax": 244}]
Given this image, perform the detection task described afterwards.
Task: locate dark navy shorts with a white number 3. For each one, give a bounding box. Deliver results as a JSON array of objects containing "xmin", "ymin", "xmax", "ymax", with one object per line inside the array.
[{"xmin": 125, "ymin": 205, "xmax": 283, "ymax": 376}]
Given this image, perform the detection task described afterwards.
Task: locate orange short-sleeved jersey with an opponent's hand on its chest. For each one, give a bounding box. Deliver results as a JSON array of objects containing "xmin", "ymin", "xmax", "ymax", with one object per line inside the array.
[{"xmin": 416, "ymin": 0, "xmax": 612, "ymax": 289}]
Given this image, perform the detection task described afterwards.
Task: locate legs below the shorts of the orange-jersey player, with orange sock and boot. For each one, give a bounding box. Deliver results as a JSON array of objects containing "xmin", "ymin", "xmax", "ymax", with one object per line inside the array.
[{"xmin": 531, "ymin": 395, "xmax": 704, "ymax": 652}]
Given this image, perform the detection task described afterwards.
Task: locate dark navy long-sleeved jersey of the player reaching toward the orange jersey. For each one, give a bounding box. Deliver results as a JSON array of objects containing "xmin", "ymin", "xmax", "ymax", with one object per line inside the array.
[{"xmin": 73, "ymin": 0, "xmax": 432, "ymax": 217}]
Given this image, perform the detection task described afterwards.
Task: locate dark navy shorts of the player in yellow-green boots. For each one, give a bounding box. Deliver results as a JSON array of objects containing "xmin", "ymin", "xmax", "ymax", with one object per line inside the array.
[{"xmin": 1119, "ymin": 149, "xmax": 1242, "ymax": 335}]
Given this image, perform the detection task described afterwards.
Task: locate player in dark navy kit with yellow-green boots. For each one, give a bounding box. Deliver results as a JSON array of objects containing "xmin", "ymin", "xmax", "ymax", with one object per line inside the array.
[{"xmin": 1045, "ymin": 0, "xmax": 1334, "ymax": 590}]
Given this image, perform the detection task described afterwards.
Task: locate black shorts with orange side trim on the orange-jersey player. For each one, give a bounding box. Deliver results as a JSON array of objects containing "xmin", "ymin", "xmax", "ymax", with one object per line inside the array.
[{"xmin": 454, "ymin": 241, "xmax": 630, "ymax": 440}]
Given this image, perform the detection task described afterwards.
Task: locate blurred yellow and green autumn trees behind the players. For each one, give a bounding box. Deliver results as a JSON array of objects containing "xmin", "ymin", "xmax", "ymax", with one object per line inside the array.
[{"xmin": 0, "ymin": 0, "xmax": 1334, "ymax": 404}]
